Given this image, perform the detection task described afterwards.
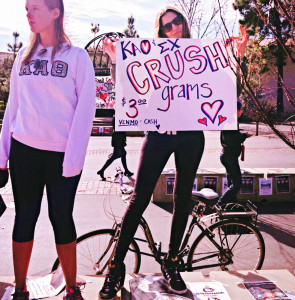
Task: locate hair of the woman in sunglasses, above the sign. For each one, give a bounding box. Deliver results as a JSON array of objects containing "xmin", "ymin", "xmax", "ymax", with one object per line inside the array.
[{"xmin": 155, "ymin": 6, "xmax": 191, "ymax": 38}]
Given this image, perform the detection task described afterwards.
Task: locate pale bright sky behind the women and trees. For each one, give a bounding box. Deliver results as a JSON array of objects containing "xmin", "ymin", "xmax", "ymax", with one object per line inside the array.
[{"xmin": 0, "ymin": 0, "xmax": 238, "ymax": 52}]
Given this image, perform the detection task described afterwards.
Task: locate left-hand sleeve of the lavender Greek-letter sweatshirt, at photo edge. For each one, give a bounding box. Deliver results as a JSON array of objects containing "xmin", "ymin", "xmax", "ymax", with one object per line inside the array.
[{"xmin": 0, "ymin": 49, "xmax": 23, "ymax": 168}]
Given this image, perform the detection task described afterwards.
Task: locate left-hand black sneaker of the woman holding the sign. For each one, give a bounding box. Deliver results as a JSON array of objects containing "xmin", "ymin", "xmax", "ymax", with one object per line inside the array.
[{"xmin": 99, "ymin": 261, "xmax": 125, "ymax": 300}]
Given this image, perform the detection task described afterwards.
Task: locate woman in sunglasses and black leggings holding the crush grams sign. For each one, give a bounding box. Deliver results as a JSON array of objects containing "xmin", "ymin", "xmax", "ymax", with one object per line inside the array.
[{"xmin": 100, "ymin": 7, "xmax": 204, "ymax": 299}]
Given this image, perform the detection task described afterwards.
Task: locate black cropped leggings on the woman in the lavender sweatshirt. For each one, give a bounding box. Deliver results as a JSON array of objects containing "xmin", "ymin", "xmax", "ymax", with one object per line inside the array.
[{"xmin": 9, "ymin": 139, "xmax": 81, "ymax": 244}]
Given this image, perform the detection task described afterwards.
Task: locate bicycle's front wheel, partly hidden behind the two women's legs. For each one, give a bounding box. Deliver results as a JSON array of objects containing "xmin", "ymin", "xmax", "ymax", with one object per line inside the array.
[{"xmin": 52, "ymin": 229, "xmax": 141, "ymax": 275}]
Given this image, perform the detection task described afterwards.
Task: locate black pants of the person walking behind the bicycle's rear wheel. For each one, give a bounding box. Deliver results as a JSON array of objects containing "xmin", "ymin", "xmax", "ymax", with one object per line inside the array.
[{"xmin": 220, "ymin": 153, "xmax": 242, "ymax": 203}]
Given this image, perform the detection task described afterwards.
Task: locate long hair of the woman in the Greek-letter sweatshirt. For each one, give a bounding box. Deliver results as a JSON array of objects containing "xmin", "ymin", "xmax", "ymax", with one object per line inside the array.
[{"xmin": 22, "ymin": 0, "xmax": 71, "ymax": 64}]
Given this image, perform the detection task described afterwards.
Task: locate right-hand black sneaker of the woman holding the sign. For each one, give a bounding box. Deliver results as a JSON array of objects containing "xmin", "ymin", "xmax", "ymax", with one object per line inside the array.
[{"xmin": 161, "ymin": 257, "xmax": 187, "ymax": 294}]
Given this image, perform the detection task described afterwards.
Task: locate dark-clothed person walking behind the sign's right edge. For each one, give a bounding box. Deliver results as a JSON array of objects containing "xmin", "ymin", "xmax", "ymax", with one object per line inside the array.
[{"xmin": 217, "ymin": 101, "xmax": 252, "ymax": 206}]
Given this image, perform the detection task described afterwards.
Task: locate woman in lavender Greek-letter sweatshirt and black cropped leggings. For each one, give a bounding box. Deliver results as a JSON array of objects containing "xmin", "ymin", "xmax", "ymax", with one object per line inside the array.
[{"xmin": 0, "ymin": 0, "xmax": 95, "ymax": 300}]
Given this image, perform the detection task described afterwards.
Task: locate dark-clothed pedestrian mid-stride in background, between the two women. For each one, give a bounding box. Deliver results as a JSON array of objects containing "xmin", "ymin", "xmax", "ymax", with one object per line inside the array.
[{"xmin": 97, "ymin": 117, "xmax": 133, "ymax": 181}]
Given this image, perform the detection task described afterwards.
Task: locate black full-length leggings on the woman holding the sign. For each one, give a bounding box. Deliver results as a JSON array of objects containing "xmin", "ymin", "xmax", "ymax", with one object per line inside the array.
[{"xmin": 114, "ymin": 131, "xmax": 204, "ymax": 262}]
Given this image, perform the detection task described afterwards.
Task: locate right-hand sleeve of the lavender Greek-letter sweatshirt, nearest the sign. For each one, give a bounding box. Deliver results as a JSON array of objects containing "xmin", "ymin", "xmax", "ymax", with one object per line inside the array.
[{"xmin": 62, "ymin": 49, "xmax": 95, "ymax": 177}]
